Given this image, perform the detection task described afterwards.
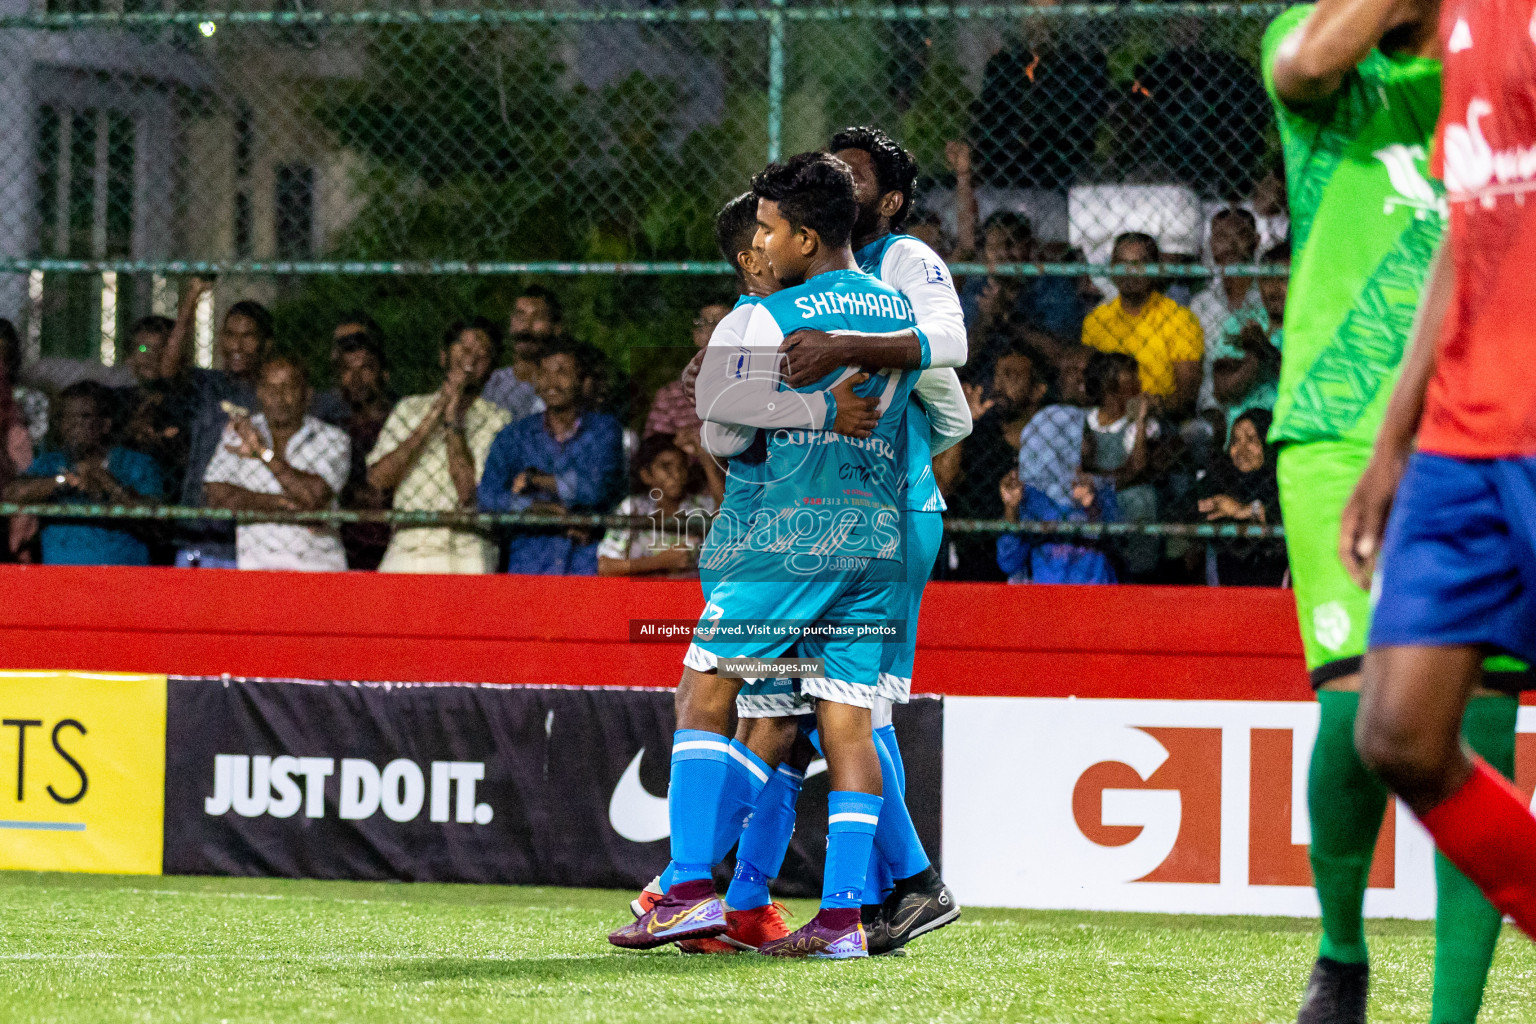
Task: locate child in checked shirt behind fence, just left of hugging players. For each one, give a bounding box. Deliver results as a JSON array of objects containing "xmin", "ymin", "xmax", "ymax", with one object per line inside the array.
[{"xmin": 598, "ymin": 434, "xmax": 719, "ymax": 579}]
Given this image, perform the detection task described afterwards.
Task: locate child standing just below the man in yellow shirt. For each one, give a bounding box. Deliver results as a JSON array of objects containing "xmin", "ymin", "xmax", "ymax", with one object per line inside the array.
[{"xmin": 1083, "ymin": 352, "xmax": 1161, "ymax": 577}]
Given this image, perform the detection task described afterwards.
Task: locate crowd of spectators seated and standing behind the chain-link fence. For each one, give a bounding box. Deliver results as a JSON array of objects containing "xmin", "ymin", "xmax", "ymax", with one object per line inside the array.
[{"xmin": 0, "ymin": 189, "xmax": 1289, "ymax": 586}]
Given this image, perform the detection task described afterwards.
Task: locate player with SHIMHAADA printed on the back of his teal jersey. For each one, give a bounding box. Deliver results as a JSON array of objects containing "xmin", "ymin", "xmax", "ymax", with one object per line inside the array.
[{"xmin": 610, "ymin": 154, "xmax": 915, "ymax": 958}]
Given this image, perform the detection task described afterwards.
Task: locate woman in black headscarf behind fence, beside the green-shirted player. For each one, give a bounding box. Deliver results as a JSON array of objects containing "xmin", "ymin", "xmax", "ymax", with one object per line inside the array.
[{"xmin": 1198, "ymin": 408, "xmax": 1286, "ymax": 586}]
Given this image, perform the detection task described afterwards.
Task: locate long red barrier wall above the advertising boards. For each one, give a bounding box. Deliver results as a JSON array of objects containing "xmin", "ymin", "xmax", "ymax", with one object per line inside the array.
[{"xmin": 0, "ymin": 567, "xmax": 1309, "ymax": 700}]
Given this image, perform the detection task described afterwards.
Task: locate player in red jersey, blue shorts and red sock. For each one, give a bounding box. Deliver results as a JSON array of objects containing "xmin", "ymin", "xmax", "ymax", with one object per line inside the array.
[{"xmin": 1339, "ymin": 0, "xmax": 1536, "ymax": 938}]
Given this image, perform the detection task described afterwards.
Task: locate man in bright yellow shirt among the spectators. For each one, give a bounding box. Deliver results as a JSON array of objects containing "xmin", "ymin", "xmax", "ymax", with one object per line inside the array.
[{"xmin": 1083, "ymin": 232, "xmax": 1206, "ymax": 419}]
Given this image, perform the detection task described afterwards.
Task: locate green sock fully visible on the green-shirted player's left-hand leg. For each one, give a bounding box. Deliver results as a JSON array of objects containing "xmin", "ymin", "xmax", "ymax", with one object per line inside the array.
[{"xmin": 1307, "ymin": 689, "xmax": 1387, "ymax": 964}]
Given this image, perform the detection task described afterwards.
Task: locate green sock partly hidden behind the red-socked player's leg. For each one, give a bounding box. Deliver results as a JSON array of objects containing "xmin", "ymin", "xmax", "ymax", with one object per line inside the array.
[{"xmin": 1430, "ymin": 695, "xmax": 1519, "ymax": 1024}]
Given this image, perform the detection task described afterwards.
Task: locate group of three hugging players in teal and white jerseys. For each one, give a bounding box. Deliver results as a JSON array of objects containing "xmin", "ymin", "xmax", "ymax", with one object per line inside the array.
[{"xmin": 610, "ymin": 129, "xmax": 971, "ymax": 960}]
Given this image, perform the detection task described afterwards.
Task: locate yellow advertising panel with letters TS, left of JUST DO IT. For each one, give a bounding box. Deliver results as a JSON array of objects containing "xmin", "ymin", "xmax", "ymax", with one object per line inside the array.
[{"xmin": 0, "ymin": 672, "xmax": 166, "ymax": 875}]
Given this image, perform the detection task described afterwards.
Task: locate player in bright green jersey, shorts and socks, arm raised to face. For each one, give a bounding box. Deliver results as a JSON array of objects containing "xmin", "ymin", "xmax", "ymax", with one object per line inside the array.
[{"xmin": 1263, "ymin": 0, "xmax": 1524, "ymax": 1024}]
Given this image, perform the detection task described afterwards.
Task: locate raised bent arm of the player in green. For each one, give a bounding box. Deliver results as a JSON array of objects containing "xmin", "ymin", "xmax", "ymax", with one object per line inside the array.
[{"xmin": 1263, "ymin": 0, "xmax": 1432, "ymax": 107}]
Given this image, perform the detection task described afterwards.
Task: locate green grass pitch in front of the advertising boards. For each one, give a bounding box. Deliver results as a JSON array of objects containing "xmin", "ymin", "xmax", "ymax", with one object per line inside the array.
[{"xmin": 0, "ymin": 874, "xmax": 1536, "ymax": 1024}]
